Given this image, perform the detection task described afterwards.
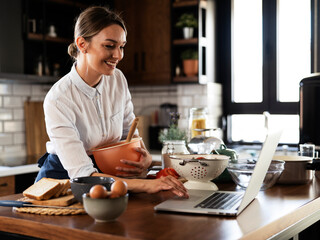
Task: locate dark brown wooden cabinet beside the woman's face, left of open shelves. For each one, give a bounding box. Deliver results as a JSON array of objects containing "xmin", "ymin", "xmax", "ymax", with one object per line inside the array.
[{"xmin": 114, "ymin": 0, "xmax": 171, "ymax": 85}]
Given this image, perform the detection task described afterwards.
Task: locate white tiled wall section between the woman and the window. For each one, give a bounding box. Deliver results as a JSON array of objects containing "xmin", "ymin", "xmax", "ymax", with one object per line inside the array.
[{"xmin": 130, "ymin": 83, "xmax": 222, "ymax": 135}]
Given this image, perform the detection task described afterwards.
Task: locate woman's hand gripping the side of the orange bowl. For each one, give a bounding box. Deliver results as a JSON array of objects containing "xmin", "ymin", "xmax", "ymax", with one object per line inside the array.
[{"xmin": 116, "ymin": 147, "xmax": 152, "ymax": 178}]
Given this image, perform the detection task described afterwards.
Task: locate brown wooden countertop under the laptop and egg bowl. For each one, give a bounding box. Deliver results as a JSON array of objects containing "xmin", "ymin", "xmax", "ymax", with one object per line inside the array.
[{"xmin": 0, "ymin": 178, "xmax": 320, "ymax": 240}]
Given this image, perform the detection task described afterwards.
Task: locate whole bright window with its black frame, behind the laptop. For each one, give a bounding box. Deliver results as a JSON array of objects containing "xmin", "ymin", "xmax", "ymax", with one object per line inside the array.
[{"xmin": 217, "ymin": 0, "xmax": 314, "ymax": 144}]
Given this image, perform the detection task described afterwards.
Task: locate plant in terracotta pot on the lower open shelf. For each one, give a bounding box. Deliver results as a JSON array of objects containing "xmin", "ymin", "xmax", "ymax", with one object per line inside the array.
[{"xmin": 181, "ymin": 48, "xmax": 199, "ymax": 77}]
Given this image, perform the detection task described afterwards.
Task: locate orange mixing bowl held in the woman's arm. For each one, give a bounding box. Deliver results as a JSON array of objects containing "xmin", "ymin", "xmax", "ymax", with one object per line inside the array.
[{"xmin": 92, "ymin": 137, "xmax": 141, "ymax": 176}]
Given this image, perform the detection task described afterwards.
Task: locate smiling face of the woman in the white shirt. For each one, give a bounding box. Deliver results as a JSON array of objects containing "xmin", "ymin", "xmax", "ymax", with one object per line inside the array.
[{"xmin": 86, "ymin": 24, "xmax": 126, "ymax": 75}]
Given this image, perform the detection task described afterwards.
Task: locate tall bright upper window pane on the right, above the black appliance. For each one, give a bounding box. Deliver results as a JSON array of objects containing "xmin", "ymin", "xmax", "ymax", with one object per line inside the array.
[{"xmin": 277, "ymin": 0, "xmax": 311, "ymax": 102}]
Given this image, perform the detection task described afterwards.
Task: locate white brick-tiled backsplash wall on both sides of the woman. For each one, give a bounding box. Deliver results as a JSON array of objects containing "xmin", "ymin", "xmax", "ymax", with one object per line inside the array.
[{"xmin": 0, "ymin": 79, "xmax": 222, "ymax": 155}]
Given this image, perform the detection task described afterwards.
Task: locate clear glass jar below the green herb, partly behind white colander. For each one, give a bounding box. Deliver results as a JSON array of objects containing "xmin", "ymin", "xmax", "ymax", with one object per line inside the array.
[{"xmin": 161, "ymin": 140, "xmax": 189, "ymax": 168}]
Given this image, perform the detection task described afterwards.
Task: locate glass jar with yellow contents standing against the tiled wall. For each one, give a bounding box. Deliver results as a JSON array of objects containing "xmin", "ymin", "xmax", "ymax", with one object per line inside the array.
[{"xmin": 189, "ymin": 107, "xmax": 208, "ymax": 139}]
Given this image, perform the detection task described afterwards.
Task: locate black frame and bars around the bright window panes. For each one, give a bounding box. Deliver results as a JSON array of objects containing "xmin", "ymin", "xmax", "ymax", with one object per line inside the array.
[{"xmin": 216, "ymin": 0, "xmax": 320, "ymax": 143}]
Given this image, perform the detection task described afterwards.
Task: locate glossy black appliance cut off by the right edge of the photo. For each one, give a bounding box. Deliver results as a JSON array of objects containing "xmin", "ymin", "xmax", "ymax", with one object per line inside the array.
[{"xmin": 299, "ymin": 73, "xmax": 320, "ymax": 149}]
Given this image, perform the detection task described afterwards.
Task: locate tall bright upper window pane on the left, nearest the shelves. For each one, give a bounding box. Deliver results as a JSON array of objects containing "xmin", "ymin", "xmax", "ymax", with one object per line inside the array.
[{"xmin": 232, "ymin": 0, "xmax": 262, "ymax": 103}]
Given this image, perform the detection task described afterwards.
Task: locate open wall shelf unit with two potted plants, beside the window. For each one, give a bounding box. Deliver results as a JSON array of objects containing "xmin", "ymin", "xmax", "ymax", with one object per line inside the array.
[{"xmin": 171, "ymin": 0, "xmax": 215, "ymax": 84}]
